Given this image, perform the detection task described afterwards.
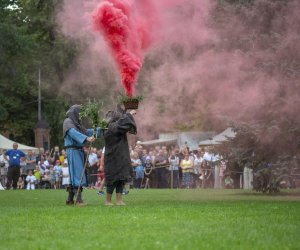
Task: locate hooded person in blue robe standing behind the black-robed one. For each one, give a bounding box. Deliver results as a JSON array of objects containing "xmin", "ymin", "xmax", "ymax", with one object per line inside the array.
[{"xmin": 63, "ymin": 104, "xmax": 100, "ymax": 205}]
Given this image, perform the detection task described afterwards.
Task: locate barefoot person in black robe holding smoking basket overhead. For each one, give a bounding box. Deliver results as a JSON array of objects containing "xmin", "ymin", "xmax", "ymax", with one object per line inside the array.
[{"xmin": 104, "ymin": 107, "xmax": 136, "ymax": 206}]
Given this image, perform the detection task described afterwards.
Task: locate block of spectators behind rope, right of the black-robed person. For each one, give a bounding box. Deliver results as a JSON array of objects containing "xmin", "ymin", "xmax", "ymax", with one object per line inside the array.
[{"xmin": 130, "ymin": 142, "xmax": 233, "ymax": 188}]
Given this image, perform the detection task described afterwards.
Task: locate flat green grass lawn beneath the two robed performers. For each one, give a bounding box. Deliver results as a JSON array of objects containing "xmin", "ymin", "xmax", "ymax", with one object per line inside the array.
[{"xmin": 0, "ymin": 190, "xmax": 300, "ymax": 249}]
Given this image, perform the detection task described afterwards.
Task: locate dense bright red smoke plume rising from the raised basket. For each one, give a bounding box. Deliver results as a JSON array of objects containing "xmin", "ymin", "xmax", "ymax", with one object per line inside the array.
[{"xmin": 93, "ymin": 0, "xmax": 150, "ymax": 96}]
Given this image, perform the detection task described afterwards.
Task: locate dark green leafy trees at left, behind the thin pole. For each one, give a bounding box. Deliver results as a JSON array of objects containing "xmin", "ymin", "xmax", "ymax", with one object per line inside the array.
[{"xmin": 0, "ymin": 0, "xmax": 76, "ymax": 145}]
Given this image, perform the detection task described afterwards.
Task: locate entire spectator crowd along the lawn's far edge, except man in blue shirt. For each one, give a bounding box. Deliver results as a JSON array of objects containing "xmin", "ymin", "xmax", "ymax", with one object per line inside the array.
[{"xmin": 0, "ymin": 142, "xmax": 233, "ymax": 189}]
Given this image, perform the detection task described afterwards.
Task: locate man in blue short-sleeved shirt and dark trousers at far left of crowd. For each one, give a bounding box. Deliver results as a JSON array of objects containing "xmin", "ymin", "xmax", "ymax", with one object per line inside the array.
[{"xmin": 4, "ymin": 143, "xmax": 25, "ymax": 190}]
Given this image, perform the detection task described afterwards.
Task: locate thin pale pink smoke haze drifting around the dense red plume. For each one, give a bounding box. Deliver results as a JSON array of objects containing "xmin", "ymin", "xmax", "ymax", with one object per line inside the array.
[{"xmin": 58, "ymin": 0, "xmax": 300, "ymax": 139}]
